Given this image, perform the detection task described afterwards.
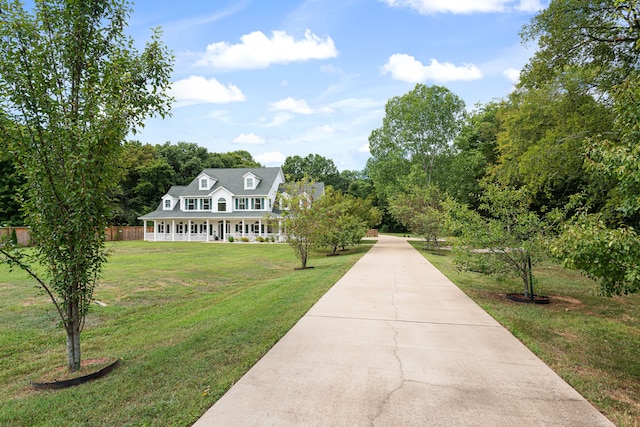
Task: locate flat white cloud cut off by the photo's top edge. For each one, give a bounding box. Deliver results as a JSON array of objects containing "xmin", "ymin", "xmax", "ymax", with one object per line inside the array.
[{"xmin": 383, "ymin": 0, "xmax": 544, "ymax": 15}]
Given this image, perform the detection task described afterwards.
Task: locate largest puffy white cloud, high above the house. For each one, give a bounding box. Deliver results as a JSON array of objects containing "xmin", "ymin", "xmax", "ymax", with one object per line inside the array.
[{"xmin": 196, "ymin": 30, "xmax": 338, "ymax": 70}]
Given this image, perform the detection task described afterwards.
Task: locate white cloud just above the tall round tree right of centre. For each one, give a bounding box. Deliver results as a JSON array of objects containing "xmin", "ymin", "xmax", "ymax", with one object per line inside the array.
[{"xmin": 382, "ymin": 53, "xmax": 482, "ymax": 83}]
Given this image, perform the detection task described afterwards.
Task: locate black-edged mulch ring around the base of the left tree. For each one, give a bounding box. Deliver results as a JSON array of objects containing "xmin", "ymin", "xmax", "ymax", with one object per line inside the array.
[{"xmin": 31, "ymin": 357, "xmax": 120, "ymax": 390}]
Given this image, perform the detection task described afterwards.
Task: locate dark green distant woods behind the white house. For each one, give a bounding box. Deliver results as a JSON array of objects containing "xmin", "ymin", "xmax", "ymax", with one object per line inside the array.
[{"xmin": 0, "ymin": 140, "xmax": 377, "ymax": 226}]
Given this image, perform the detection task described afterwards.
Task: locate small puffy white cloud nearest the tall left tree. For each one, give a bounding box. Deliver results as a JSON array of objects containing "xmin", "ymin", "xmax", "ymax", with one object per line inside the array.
[{"xmin": 170, "ymin": 76, "xmax": 246, "ymax": 107}]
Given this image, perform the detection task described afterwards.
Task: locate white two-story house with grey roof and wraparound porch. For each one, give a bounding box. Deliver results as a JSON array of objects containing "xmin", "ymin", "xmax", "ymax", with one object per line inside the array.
[{"xmin": 139, "ymin": 167, "xmax": 284, "ymax": 241}]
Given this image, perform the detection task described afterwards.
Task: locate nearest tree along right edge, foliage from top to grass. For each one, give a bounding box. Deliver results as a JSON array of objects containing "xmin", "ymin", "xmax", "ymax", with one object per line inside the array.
[{"xmin": 522, "ymin": 0, "xmax": 640, "ymax": 295}]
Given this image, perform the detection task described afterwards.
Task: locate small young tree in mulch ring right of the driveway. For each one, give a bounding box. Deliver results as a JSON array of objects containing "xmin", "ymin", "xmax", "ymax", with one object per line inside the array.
[{"xmin": 444, "ymin": 184, "xmax": 547, "ymax": 301}]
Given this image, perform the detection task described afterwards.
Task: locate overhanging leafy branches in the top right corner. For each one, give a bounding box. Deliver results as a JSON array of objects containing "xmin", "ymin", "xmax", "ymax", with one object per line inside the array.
[{"xmin": 521, "ymin": 0, "xmax": 640, "ymax": 93}]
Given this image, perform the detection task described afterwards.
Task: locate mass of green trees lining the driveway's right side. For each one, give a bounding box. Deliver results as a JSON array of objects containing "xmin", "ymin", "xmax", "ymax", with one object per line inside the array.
[{"xmin": 367, "ymin": 0, "xmax": 640, "ymax": 295}]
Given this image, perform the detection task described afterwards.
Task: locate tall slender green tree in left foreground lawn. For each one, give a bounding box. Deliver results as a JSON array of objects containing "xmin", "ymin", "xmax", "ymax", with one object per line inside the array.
[{"xmin": 0, "ymin": 0, "xmax": 173, "ymax": 371}]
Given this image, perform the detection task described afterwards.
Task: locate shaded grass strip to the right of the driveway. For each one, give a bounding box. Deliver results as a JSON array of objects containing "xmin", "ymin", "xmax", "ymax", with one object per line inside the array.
[{"xmin": 411, "ymin": 242, "xmax": 640, "ymax": 426}]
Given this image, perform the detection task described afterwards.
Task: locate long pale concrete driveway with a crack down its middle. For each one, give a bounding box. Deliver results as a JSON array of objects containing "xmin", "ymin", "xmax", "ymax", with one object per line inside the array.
[{"xmin": 194, "ymin": 236, "xmax": 613, "ymax": 427}]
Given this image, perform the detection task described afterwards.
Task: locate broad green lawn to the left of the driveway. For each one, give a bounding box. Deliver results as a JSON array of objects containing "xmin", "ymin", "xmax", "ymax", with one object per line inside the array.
[{"xmin": 0, "ymin": 242, "xmax": 372, "ymax": 426}]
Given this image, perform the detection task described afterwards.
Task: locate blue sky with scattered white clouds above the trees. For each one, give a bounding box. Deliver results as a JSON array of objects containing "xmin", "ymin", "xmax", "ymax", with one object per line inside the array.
[{"xmin": 129, "ymin": 0, "xmax": 548, "ymax": 170}]
